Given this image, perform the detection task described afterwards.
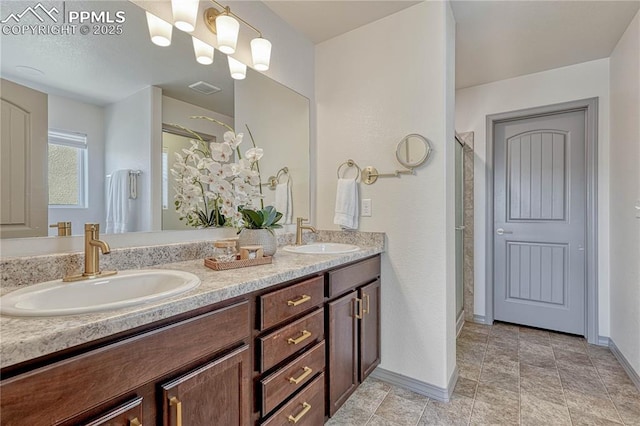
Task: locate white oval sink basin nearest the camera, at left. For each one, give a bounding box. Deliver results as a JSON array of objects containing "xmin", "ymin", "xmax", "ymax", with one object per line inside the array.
[{"xmin": 0, "ymin": 269, "xmax": 200, "ymax": 317}]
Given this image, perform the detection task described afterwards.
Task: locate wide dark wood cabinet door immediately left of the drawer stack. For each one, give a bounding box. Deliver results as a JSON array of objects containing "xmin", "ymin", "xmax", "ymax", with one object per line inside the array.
[{"xmin": 162, "ymin": 345, "xmax": 251, "ymax": 426}]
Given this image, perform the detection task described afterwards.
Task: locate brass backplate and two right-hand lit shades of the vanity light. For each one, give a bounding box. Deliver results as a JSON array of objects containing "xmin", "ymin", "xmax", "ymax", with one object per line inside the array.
[{"xmin": 204, "ymin": 0, "xmax": 271, "ymax": 71}]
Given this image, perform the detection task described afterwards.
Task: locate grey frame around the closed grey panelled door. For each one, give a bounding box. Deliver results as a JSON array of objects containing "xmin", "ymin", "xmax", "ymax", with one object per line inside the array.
[{"xmin": 485, "ymin": 97, "xmax": 599, "ymax": 344}]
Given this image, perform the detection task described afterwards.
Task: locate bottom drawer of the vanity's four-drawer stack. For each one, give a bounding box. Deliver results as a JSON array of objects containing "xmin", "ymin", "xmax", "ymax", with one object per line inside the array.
[{"xmin": 262, "ymin": 373, "xmax": 324, "ymax": 426}]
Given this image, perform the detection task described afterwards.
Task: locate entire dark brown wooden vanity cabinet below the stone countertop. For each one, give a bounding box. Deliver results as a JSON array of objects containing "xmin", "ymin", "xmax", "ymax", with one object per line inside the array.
[{"xmin": 0, "ymin": 256, "xmax": 380, "ymax": 426}]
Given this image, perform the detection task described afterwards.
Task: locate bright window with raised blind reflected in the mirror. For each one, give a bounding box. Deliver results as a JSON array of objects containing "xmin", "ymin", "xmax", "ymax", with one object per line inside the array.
[{"xmin": 48, "ymin": 130, "xmax": 87, "ymax": 208}]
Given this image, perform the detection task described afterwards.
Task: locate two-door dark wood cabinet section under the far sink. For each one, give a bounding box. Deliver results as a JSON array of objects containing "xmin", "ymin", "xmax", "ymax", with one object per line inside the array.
[{"xmin": 325, "ymin": 256, "xmax": 380, "ymax": 416}]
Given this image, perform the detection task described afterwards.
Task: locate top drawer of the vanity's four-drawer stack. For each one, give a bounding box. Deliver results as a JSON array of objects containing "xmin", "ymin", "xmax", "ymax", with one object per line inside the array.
[{"xmin": 259, "ymin": 276, "xmax": 324, "ymax": 330}]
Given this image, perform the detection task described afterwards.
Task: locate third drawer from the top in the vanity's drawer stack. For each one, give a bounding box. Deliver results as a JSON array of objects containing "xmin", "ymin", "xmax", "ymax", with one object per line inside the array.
[{"xmin": 260, "ymin": 340, "xmax": 325, "ymax": 415}]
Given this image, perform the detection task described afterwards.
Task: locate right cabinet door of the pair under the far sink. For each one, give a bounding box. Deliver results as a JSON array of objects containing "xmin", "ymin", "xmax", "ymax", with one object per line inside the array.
[{"xmin": 360, "ymin": 280, "xmax": 380, "ymax": 382}]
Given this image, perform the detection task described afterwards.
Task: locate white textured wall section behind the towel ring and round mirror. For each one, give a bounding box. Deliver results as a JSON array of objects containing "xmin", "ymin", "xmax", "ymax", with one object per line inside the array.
[{"xmin": 316, "ymin": 2, "xmax": 455, "ymax": 388}]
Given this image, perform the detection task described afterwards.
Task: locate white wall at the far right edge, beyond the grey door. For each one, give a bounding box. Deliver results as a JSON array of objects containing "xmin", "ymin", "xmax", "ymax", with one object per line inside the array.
[{"xmin": 609, "ymin": 13, "xmax": 640, "ymax": 374}]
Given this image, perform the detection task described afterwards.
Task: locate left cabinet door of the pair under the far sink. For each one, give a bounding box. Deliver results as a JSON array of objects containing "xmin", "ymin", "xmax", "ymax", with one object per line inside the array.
[{"xmin": 327, "ymin": 291, "xmax": 358, "ymax": 416}]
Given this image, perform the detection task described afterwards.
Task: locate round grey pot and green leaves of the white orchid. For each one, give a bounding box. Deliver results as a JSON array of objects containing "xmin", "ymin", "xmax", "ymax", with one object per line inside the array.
[{"xmin": 238, "ymin": 206, "xmax": 282, "ymax": 256}]
